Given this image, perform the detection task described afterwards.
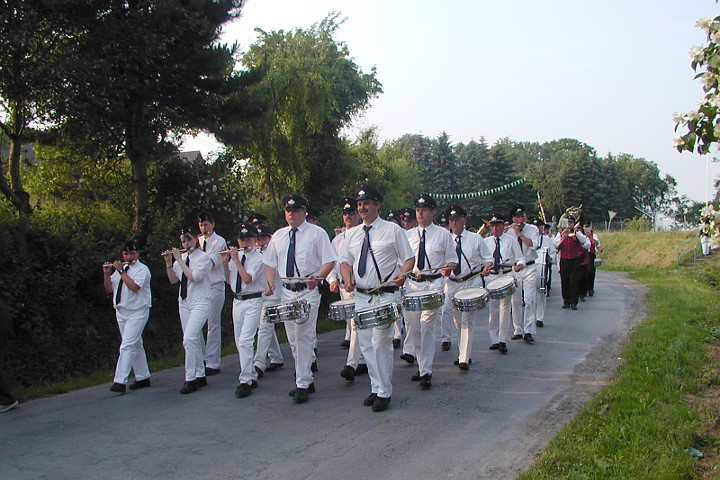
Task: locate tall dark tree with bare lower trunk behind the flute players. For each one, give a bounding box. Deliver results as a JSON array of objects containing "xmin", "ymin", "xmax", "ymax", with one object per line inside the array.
[{"xmin": 47, "ymin": 0, "xmax": 248, "ymax": 243}]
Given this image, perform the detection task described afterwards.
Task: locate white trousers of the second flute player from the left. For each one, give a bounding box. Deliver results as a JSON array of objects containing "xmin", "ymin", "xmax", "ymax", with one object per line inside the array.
[{"xmin": 178, "ymin": 300, "xmax": 210, "ymax": 382}]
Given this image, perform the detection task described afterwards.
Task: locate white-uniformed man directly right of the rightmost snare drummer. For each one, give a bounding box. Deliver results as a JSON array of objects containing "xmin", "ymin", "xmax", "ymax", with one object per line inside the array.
[{"xmin": 507, "ymin": 205, "xmax": 540, "ymax": 344}]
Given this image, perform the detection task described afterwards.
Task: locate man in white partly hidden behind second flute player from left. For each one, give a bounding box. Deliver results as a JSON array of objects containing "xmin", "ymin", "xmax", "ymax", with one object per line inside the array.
[{"xmin": 198, "ymin": 212, "xmax": 227, "ymax": 376}]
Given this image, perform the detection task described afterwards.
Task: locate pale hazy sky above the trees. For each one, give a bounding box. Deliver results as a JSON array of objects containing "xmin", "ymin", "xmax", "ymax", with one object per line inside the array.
[{"xmin": 184, "ymin": 0, "xmax": 720, "ymax": 202}]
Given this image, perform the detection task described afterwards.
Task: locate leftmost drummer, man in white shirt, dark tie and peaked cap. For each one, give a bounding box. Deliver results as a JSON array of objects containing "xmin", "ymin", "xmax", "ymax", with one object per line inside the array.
[{"xmin": 263, "ymin": 193, "xmax": 337, "ymax": 403}]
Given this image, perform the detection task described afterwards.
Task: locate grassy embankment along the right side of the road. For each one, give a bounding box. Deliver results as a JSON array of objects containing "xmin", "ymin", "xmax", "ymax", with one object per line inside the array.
[{"xmin": 520, "ymin": 232, "xmax": 720, "ymax": 480}]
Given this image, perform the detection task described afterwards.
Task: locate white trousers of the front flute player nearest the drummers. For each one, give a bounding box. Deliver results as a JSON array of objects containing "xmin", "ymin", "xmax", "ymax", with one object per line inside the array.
[{"xmin": 233, "ymin": 298, "xmax": 262, "ymax": 385}]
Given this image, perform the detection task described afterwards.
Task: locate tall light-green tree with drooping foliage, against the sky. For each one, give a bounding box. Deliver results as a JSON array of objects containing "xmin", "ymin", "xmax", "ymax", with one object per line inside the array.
[{"xmin": 220, "ymin": 13, "xmax": 381, "ymax": 219}]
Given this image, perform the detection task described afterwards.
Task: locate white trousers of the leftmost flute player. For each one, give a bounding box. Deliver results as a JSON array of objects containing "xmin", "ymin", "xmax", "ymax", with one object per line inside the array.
[{"xmin": 113, "ymin": 308, "xmax": 150, "ymax": 384}]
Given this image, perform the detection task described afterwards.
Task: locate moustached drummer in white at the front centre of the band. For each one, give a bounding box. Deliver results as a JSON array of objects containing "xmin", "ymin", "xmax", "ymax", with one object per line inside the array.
[{"xmin": 340, "ymin": 185, "xmax": 414, "ymax": 412}]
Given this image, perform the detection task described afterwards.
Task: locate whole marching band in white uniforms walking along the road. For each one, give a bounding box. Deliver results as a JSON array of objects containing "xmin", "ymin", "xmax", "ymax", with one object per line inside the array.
[{"xmin": 102, "ymin": 189, "xmax": 602, "ymax": 412}]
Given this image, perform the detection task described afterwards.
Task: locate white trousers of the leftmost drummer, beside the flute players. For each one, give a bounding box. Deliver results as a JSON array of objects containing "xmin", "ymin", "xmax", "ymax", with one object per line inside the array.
[{"xmin": 279, "ymin": 287, "xmax": 320, "ymax": 388}]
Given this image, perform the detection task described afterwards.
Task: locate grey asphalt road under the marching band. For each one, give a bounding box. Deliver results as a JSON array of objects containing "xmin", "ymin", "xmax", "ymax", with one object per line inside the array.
[{"xmin": 0, "ymin": 272, "xmax": 644, "ymax": 480}]
